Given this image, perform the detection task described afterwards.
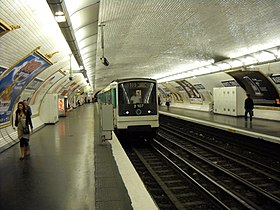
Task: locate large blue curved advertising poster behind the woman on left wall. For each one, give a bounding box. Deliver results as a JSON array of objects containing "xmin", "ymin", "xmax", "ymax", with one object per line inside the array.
[{"xmin": 0, "ymin": 51, "xmax": 52, "ymax": 126}]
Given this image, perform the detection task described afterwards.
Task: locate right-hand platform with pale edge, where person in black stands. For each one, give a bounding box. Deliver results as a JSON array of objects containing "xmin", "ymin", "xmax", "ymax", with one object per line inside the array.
[{"xmin": 160, "ymin": 106, "xmax": 280, "ymax": 144}]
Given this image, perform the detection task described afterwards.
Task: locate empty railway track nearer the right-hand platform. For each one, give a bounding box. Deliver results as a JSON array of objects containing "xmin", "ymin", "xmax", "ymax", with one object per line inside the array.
[{"xmin": 153, "ymin": 127, "xmax": 280, "ymax": 209}]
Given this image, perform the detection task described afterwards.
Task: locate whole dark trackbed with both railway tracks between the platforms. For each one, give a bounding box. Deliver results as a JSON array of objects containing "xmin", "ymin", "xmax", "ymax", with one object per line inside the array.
[{"xmin": 120, "ymin": 115, "xmax": 280, "ymax": 210}]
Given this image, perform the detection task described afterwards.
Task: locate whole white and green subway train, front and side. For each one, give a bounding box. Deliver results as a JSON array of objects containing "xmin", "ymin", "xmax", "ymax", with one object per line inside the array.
[{"xmin": 96, "ymin": 78, "xmax": 159, "ymax": 137}]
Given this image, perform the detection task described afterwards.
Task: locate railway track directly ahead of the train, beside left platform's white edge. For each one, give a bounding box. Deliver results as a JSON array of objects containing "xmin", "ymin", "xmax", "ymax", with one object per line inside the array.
[{"xmin": 126, "ymin": 145, "xmax": 229, "ymax": 210}]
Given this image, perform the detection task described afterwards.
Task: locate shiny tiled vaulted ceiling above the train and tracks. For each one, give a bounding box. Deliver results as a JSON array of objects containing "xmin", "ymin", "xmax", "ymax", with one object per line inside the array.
[{"xmin": 96, "ymin": 0, "xmax": 280, "ymax": 86}]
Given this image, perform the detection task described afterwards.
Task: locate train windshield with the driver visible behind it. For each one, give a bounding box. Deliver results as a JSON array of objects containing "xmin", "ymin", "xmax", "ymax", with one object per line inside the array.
[{"xmin": 119, "ymin": 81, "xmax": 156, "ymax": 104}]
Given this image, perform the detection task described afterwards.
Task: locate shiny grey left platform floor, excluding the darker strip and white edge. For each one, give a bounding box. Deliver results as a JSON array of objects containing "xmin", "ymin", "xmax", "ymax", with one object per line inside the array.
[{"xmin": 0, "ymin": 104, "xmax": 95, "ymax": 210}]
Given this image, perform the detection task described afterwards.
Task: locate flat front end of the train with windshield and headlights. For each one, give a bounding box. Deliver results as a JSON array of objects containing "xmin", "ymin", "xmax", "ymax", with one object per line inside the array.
[{"xmin": 117, "ymin": 80, "xmax": 159, "ymax": 135}]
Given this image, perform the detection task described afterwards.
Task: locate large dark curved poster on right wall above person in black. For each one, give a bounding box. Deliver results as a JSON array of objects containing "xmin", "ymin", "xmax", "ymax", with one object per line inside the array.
[{"xmin": 227, "ymin": 71, "xmax": 280, "ymax": 106}]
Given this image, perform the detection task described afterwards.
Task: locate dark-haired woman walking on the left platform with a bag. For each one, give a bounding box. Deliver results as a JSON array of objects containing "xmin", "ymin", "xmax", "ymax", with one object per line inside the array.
[{"xmin": 15, "ymin": 102, "xmax": 33, "ymax": 160}]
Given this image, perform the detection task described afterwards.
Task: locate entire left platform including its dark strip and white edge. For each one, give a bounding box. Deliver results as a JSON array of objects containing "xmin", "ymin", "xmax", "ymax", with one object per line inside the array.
[{"xmin": 0, "ymin": 104, "xmax": 158, "ymax": 210}]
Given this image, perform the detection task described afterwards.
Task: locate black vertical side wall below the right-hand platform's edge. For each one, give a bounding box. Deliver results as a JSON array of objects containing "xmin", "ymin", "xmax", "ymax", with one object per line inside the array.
[{"xmin": 160, "ymin": 115, "xmax": 280, "ymax": 171}]
